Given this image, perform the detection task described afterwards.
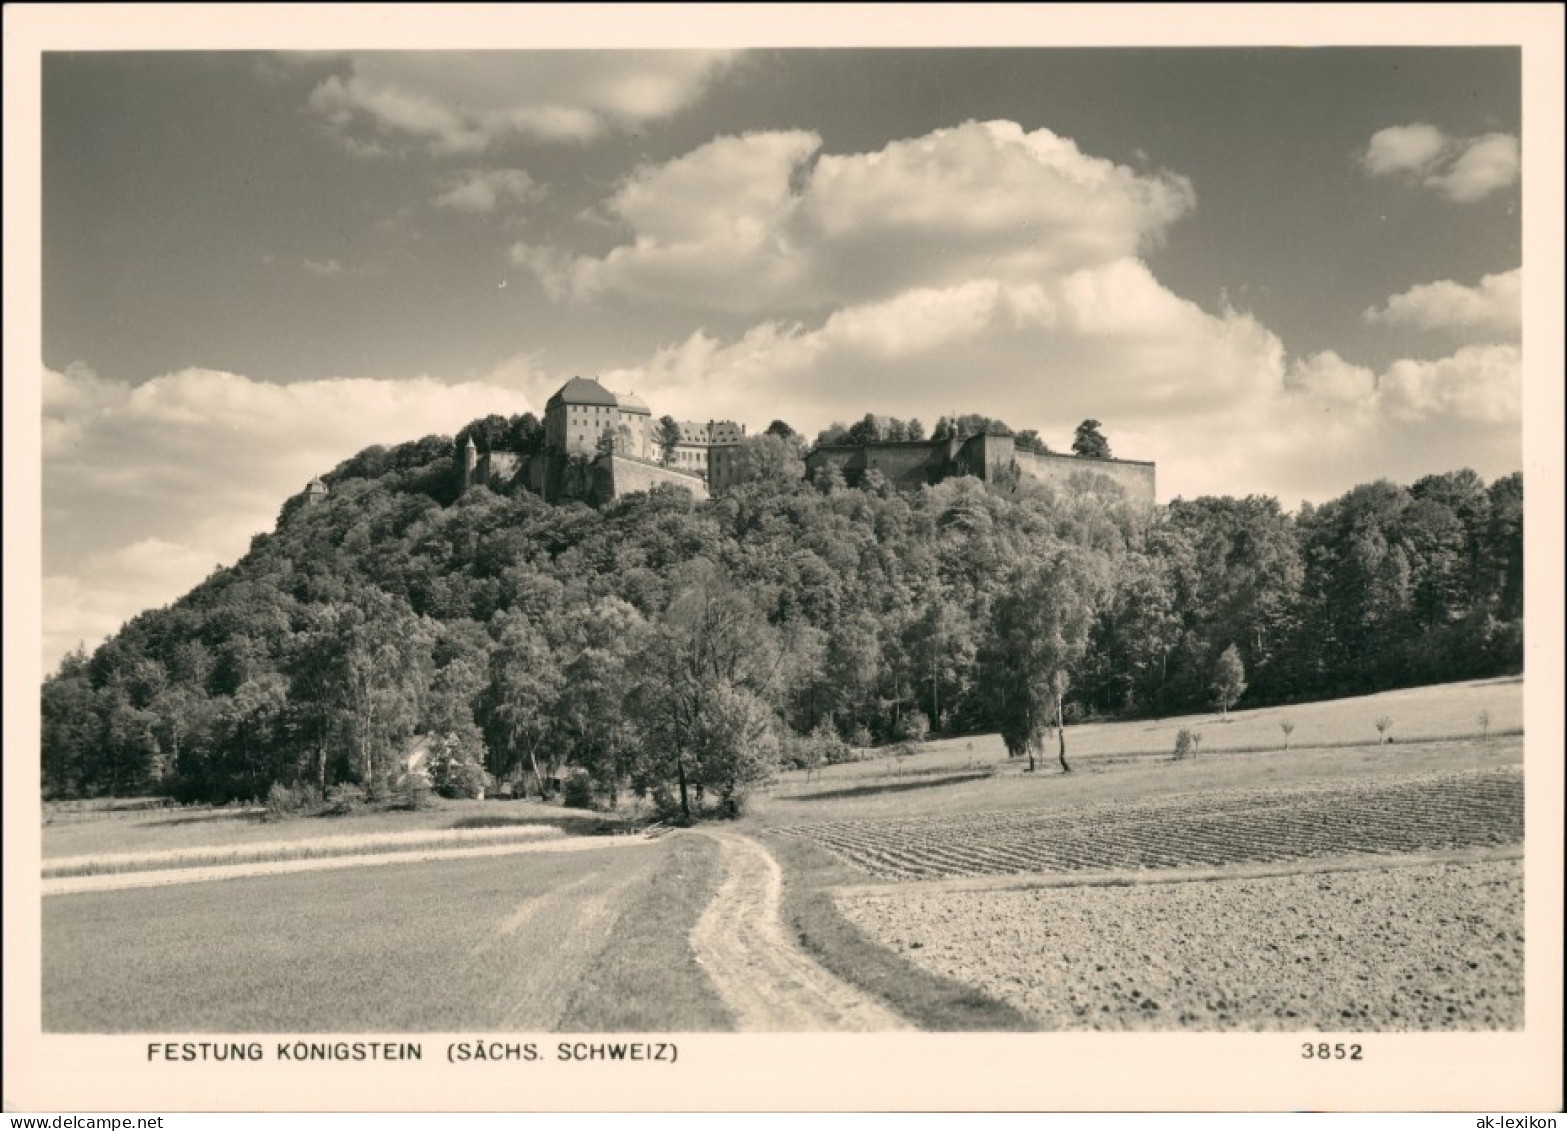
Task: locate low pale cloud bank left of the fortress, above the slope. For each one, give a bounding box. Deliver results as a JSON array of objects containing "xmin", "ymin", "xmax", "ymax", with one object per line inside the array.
[{"xmin": 42, "ymin": 359, "xmax": 533, "ymax": 667}]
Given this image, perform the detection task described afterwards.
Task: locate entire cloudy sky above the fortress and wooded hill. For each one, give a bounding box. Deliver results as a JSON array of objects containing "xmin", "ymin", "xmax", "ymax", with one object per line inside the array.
[{"xmin": 30, "ymin": 33, "xmax": 1526, "ymax": 669}]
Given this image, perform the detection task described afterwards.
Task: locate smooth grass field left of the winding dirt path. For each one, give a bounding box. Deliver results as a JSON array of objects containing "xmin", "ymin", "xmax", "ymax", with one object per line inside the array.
[{"xmin": 42, "ymin": 838, "xmax": 726, "ymax": 1032}]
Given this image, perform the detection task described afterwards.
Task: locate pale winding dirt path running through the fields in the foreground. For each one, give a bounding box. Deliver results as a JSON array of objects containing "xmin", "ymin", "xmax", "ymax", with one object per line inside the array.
[{"xmin": 691, "ymin": 830, "xmax": 909, "ymax": 1032}]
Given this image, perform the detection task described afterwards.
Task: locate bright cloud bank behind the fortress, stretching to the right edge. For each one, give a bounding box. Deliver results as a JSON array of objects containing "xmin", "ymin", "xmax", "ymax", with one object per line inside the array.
[{"xmin": 603, "ymin": 258, "xmax": 1522, "ymax": 506}]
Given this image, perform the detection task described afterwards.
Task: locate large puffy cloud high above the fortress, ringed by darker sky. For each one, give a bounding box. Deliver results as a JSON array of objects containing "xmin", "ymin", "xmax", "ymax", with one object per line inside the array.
[{"xmin": 512, "ymin": 122, "xmax": 1196, "ymax": 312}]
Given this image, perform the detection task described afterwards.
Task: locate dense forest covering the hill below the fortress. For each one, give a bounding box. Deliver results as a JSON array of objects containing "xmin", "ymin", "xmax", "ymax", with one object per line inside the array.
[{"xmin": 42, "ymin": 417, "xmax": 1523, "ymax": 815}]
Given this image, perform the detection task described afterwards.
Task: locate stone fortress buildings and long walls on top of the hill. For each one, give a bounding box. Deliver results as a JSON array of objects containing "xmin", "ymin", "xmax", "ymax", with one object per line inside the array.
[{"xmin": 454, "ymin": 378, "xmax": 1155, "ymax": 506}]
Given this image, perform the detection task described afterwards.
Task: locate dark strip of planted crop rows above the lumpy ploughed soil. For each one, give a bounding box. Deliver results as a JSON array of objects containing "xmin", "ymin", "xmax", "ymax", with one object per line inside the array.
[{"xmin": 780, "ymin": 769, "xmax": 1523, "ymax": 879}]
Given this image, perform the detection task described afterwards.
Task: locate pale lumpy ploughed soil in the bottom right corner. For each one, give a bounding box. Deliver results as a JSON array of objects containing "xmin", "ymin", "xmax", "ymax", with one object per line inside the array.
[{"xmin": 838, "ymin": 860, "xmax": 1523, "ymax": 1032}]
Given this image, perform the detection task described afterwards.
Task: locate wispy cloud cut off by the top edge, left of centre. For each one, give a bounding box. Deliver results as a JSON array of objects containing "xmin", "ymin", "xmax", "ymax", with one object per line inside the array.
[{"xmin": 310, "ymin": 52, "xmax": 736, "ymax": 155}]
